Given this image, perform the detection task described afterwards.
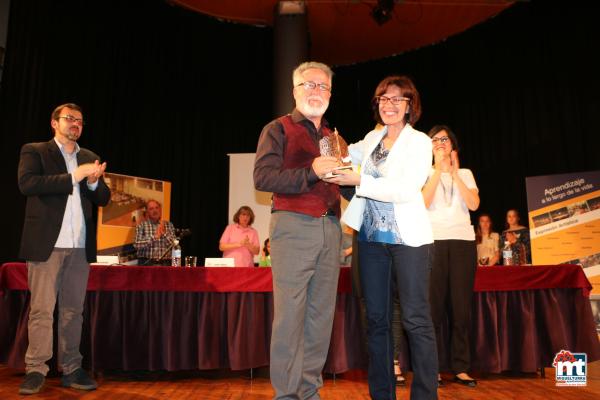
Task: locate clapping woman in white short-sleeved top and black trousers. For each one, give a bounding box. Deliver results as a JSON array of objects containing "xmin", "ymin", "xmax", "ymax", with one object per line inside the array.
[{"xmin": 423, "ymin": 125, "xmax": 479, "ymax": 387}]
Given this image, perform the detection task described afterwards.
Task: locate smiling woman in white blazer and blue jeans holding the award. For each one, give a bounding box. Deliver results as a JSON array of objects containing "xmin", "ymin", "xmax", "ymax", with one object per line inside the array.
[{"xmin": 328, "ymin": 76, "xmax": 438, "ymax": 400}]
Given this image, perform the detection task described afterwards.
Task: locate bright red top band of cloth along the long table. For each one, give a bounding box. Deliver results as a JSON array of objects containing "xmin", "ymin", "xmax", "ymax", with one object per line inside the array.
[{"xmin": 0, "ymin": 263, "xmax": 592, "ymax": 295}]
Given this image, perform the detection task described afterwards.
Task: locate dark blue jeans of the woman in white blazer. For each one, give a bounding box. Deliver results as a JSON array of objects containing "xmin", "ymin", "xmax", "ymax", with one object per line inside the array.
[{"xmin": 358, "ymin": 242, "xmax": 438, "ymax": 400}]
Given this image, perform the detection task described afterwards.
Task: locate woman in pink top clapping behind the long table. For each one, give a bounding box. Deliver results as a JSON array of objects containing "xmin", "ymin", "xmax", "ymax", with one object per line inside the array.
[{"xmin": 219, "ymin": 206, "xmax": 260, "ymax": 267}]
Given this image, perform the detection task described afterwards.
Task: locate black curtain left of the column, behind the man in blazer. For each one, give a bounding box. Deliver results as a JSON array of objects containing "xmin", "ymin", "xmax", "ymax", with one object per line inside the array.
[{"xmin": 0, "ymin": 0, "xmax": 272, "ymax": 262}]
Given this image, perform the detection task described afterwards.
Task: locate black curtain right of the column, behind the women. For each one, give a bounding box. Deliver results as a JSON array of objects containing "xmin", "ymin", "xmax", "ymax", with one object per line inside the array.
[{"xmin": 329, "ymin": 1, "xmax": 600, "ymax": 236}]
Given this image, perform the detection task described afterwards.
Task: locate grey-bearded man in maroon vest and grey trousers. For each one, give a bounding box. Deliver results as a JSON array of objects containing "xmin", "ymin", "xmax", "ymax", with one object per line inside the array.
[{"xmin": 254, "ymin": 62, "xmax": 341, "ymax": 399}]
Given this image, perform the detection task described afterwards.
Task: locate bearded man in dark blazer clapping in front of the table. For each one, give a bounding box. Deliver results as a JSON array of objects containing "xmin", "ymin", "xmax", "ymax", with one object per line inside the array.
[{"xmin": 18, "ymin": 103, "xmax": 110, "ymax": 394}]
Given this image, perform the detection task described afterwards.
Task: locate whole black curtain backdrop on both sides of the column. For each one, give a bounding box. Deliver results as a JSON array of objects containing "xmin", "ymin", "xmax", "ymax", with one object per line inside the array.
[{"xmin": 0, "ymin": 0, "xmax": 600, "ymax": 261}]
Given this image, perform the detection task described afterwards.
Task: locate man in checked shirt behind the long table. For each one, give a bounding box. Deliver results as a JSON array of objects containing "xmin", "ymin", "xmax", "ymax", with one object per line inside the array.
[{"xmin": 133, "ymin": 200, "xmax": 175, "ymax": 265}]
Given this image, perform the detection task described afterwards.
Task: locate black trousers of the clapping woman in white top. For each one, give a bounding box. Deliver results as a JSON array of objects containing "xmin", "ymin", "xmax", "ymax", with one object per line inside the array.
[{"xmin": 429, "ymin": 240, "xmax": 477, "ymax": 374}]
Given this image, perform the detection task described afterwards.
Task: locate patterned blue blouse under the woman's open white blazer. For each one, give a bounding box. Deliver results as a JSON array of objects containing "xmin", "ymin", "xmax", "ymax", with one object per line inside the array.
[{"xmin": 358, "ymin": 141, "xmax": 403, "ymax": 244}]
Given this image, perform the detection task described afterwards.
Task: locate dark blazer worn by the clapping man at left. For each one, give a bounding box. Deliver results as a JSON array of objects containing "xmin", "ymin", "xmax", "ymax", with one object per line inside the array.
[{"xmin": 18, "ymin": 139, "xmax": 110, "ymax": 262}]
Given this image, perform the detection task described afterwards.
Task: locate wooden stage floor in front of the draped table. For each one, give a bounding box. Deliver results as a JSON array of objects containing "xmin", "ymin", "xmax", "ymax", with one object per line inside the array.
[{"xmin": 0, "ymin": 361, "xmax": 600, "ymax": 400}]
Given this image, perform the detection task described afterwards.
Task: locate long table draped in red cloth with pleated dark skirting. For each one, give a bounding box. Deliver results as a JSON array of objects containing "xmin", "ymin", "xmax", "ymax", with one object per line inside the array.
[{"xmin": 0, "ymin": 263, "xmax": 600, "ymax": 373}]
